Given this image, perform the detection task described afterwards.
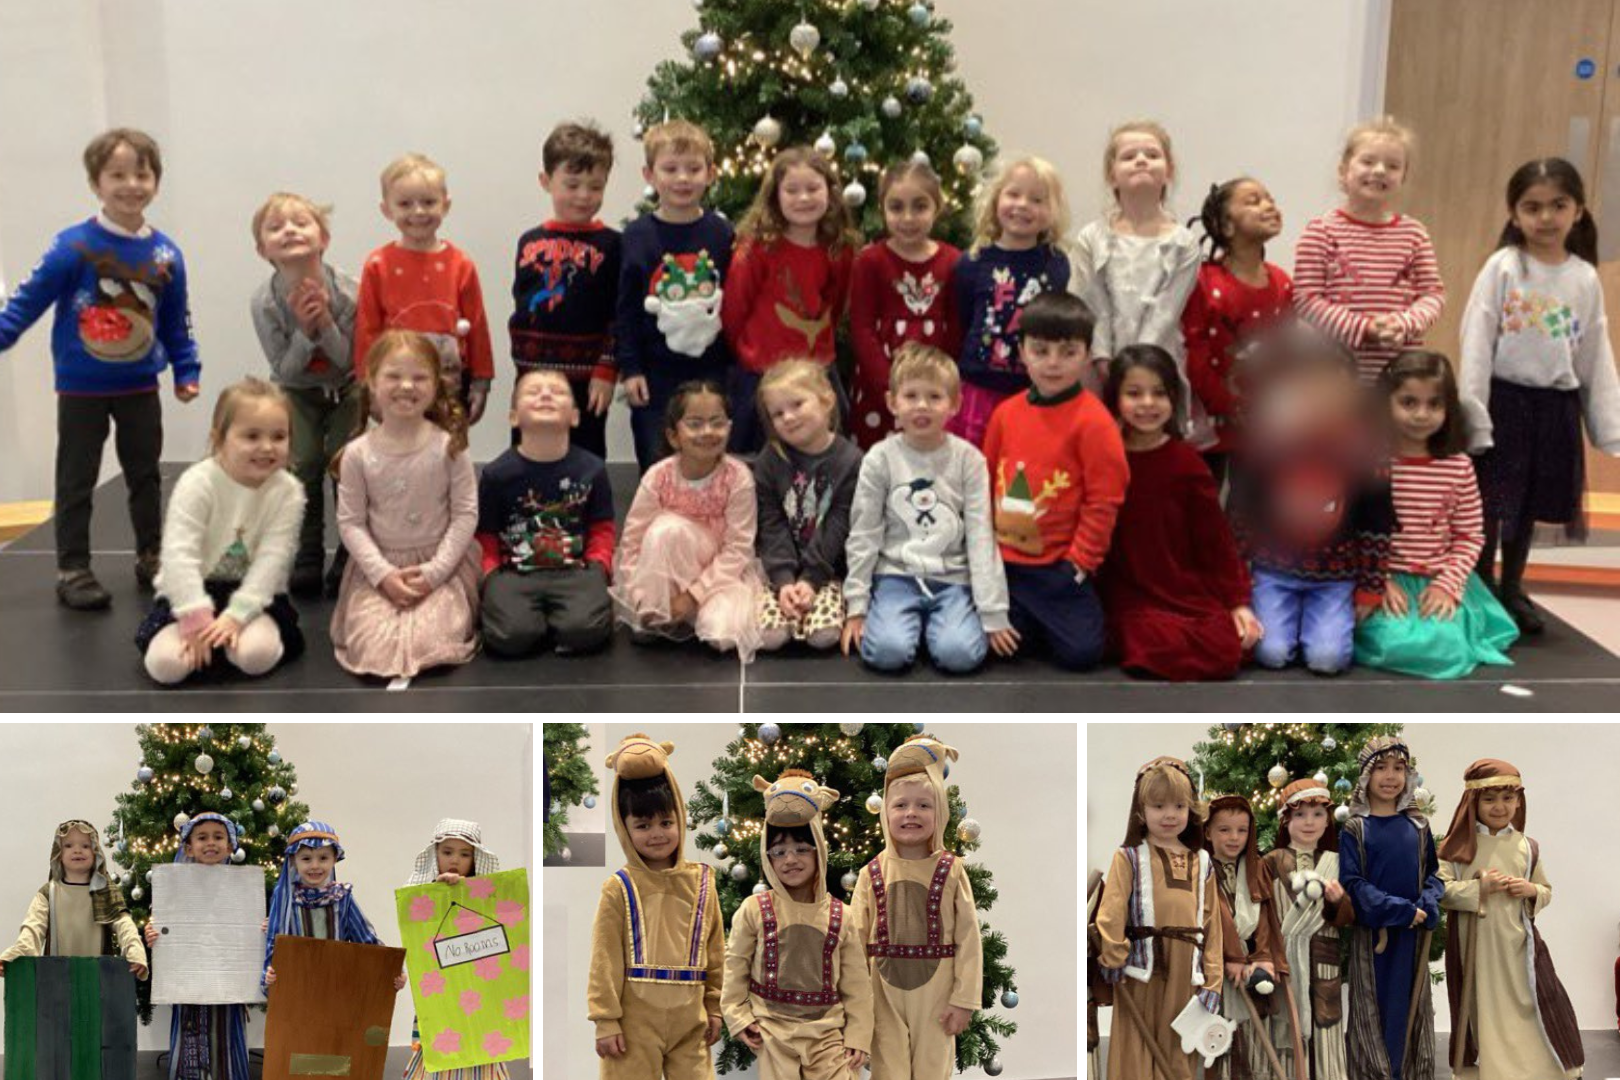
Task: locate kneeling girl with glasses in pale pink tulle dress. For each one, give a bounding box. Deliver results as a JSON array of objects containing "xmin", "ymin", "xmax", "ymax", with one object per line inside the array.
[{"xmin": 608, "ymin": 382, "xmax": 760, "ymax": 662}]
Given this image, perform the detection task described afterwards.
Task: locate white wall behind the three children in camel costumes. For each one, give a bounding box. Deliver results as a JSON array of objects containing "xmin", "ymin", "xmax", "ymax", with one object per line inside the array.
[{"xmin": 541, "ymin": 721, "xmax": 1079, "ymax": 1080}]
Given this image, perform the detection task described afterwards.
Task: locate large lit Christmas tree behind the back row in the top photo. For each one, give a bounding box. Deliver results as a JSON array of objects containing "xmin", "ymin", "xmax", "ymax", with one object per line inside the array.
[{"xmin": 633, "ymin": 0, "xmax": 996, "ymax": 246}]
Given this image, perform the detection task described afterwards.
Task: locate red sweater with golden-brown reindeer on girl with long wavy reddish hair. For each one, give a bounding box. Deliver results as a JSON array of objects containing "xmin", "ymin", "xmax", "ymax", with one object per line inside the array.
[{"xmin": 719, "ymin": 240, "xmax": 855, "ymax": 374}]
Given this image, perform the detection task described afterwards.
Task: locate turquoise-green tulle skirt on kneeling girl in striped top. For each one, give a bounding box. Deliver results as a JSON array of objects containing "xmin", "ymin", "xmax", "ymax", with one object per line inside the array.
[{"xmin": 1356, "ymin": 573, "xmax": 1518, "ymax": 678}]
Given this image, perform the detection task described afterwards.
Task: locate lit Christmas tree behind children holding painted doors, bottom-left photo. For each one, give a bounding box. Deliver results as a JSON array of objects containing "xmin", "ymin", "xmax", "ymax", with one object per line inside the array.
[{"xmin": 105, "ymin": 724, "xmax": 309, "ymax": 1020}]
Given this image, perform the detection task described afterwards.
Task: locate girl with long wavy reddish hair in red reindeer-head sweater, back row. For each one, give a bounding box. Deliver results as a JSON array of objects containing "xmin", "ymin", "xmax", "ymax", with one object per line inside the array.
[{"xmin": 719, "ymin": 146, "xmax": 859, "ymax": 453}]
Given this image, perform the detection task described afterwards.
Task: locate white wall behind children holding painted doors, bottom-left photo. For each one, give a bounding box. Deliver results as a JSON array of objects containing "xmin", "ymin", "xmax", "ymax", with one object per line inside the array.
[{"xmin": 0, "ymin": 724, "xmax": 535, "ymax": 1049}]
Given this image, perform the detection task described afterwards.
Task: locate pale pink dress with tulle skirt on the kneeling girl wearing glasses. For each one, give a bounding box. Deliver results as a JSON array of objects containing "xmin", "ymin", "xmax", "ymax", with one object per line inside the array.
[{"xmin": 609, "ymin": 455, "xmax": 761, "ymax": 662}]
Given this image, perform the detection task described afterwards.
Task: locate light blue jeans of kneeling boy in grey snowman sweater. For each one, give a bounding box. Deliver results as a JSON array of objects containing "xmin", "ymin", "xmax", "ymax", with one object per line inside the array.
[{"xmin": 860, "ymin": 573, "xmax": 988, "ymax": 672}]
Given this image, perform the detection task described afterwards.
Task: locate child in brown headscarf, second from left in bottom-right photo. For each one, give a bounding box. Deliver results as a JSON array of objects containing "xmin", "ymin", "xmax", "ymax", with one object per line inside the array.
[{"xmin": 1211, "ymin": 793, "xmax": 1290, "ymax": 1080}]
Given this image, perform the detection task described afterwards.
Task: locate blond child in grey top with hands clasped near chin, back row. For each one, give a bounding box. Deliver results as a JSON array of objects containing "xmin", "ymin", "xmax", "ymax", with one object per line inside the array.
[{"xmin": 248, "ymin": 191, "xmax": 360, "ymax": 597}]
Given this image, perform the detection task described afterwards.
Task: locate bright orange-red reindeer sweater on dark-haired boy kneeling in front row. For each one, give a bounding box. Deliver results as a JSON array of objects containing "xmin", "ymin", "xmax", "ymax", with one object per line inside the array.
[{"xmin": 983, "ymin": 384, "xmax": 1131, "ymax": 573}]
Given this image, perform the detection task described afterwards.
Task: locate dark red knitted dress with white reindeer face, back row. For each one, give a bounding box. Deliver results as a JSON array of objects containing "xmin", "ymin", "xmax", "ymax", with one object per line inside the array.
[{"xmin": 849, "ymin": 240, "xmax": 962, "ymax": 450}]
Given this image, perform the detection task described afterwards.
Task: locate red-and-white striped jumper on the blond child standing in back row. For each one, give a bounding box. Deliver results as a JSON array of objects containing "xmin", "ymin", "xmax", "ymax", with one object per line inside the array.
[{"xmin": 1294, "ymin": 209, "xmax": 1445, "ymax": 382}]
